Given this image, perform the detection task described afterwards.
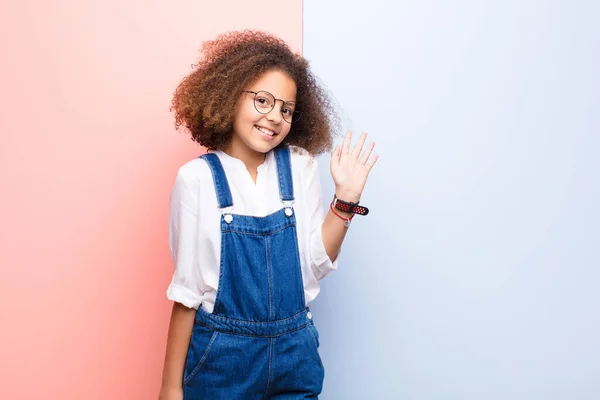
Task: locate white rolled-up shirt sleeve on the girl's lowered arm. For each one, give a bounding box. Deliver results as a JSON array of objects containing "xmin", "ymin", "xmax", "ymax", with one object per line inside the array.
[{"xmin": 167, "ymin": 170, "xmax": 202, "ymax": 309}]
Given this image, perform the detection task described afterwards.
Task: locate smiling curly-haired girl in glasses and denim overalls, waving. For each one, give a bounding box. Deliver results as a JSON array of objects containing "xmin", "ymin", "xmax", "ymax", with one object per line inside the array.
[{"xmin": 160, "ymin": 31, "xmax": 377, "ymax": 400}]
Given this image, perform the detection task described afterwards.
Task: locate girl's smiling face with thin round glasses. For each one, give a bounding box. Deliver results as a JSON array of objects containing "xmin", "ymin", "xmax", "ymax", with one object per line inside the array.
[{"xmin": 227, "ymin": 71, "xmax": 296, "ymax": 159}]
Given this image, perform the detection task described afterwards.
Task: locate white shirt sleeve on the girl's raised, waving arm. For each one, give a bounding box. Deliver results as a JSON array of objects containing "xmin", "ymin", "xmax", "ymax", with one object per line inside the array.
[{"xmin": 305, "ymin": 158, "xmax": 339, "ymax": 279}]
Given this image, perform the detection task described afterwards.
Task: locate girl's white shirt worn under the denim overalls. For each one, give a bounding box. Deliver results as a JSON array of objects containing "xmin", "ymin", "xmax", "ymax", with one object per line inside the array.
[{"xmin": 167, "ymin": 149, "xmax": 337, "ymax": 313}]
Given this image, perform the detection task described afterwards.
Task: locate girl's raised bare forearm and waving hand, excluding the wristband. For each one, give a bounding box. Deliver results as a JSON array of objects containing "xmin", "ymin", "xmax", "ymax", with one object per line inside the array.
[{"xmin": 321, "ymin": 133, "xmax": 377, "ymax": 260}]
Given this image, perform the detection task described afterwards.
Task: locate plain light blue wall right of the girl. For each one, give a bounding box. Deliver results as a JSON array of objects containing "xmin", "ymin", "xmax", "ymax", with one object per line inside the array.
[{"xmin": 304, "ymin": 0, "xmax": 600, "ymax": 400}]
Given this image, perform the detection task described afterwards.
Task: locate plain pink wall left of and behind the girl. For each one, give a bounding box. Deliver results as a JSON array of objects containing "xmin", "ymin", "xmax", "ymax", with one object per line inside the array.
[{"xmin": 0, "ymin": 0, "xmax": 302, "ymax": 400}]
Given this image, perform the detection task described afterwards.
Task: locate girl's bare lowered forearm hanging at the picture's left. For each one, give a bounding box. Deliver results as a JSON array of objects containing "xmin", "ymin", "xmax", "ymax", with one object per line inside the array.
[{"xmin": 162, "ymin": 302, "xmax": 196, "ymax": 388}]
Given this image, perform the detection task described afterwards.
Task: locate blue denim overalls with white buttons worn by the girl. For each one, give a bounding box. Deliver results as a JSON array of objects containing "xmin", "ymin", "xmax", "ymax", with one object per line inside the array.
[{"xmin": 183, "ymin": 147, "xmax": 324, "ymax": 400}]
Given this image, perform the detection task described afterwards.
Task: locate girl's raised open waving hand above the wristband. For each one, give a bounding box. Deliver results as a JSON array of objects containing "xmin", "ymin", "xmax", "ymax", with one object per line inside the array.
[{"xmin": 330, "ymin": 132, "xmax": 378, "ymax": 203}]
